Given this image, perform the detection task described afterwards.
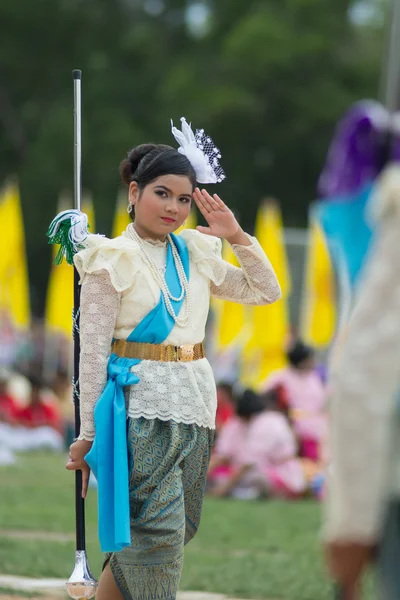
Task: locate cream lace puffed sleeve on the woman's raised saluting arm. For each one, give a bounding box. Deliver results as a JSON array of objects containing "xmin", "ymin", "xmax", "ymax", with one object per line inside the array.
[{"xmin": 181, "ymin": 230, "xmax": 281, "ymax": 305}]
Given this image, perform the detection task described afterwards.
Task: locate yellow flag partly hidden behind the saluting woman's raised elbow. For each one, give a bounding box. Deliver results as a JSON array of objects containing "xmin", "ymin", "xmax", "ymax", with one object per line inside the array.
[{"xmin": 243, "ymin": 202, "xmax": 291, "ymax": 388}]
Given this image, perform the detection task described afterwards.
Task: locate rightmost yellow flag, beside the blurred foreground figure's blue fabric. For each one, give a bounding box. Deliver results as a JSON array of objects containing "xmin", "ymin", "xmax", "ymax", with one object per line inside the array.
[{"xmin": 301, "ymin": 217, "xmax": 336, "ymax": 348}]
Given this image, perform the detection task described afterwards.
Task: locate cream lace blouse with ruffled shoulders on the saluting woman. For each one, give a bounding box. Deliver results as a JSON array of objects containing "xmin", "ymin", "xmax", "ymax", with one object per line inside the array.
[{"xmin": 75, "ymin": 225, "xmax": 280, "ymax": 440}]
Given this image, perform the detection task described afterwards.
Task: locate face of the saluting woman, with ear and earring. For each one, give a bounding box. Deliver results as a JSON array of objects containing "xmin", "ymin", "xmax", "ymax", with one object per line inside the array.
[{"xmin": 129, "ymin": 175, "xmax": 193, "ymax": 240}]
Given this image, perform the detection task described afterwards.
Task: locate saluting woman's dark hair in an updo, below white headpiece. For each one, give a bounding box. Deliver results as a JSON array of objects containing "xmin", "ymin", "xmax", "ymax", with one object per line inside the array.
[{"xmin": 119, "ymin": 144, "xmax": 196, "ymax": 190}]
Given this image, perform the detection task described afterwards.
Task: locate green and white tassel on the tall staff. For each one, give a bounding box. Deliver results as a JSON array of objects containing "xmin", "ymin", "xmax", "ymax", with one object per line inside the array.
[{"xmin": 46, "ymin": 209, "xmax": 89, "ymax": 265}]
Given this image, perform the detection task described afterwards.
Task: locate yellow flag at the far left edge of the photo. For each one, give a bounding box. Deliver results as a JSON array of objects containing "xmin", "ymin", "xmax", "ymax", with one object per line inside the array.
[{"xmin": 0, "ymin": 182, "xmax": 31, "ymax": 330}]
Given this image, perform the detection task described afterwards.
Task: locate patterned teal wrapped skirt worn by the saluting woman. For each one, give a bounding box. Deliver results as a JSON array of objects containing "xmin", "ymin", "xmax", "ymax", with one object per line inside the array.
[{"xmin": 109, "ymin": 418, "xmax": 214, "ymax": 600}]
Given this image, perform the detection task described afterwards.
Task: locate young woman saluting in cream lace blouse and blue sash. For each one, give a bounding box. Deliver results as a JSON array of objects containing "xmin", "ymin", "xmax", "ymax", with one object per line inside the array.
[{"xmin": 67, "ymin": 120, "xmax": 280, "ymax": 600}]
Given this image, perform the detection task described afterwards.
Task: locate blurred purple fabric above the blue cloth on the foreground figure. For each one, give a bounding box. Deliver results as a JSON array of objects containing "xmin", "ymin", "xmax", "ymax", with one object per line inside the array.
[{"xmin": 318, "ymin": 101, "xmax": 394, "ymax": 200}]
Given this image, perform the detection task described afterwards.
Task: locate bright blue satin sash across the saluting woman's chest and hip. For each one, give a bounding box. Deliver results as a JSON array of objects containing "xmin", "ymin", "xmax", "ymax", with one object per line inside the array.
[{"xmin": 85, "ymin": 234, "xmax": 189, "ymax": 552}]
